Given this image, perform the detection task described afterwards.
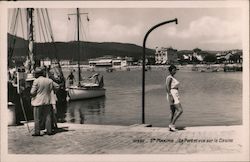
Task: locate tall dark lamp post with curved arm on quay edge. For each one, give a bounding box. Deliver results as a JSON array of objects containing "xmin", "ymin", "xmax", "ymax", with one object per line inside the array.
[{"xmin": 142, "ymin": 18, "xmax": 178, "ymax": 124}]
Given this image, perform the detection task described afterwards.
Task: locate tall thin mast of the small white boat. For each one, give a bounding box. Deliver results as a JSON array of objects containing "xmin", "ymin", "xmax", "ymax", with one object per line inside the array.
[{"xmin": 77, "ymin": 8, "xmax": 82, "ymax": 86}]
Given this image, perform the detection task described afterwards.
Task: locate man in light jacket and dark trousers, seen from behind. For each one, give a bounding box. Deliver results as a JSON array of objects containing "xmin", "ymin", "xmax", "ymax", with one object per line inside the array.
[{"xmin": 30, "ymin": 67, "xmax": 59, "ymax": 136}]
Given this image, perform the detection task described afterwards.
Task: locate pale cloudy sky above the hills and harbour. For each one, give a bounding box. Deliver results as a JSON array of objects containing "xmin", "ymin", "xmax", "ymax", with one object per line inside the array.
[{"xmin": 9, "ymin": 8, "xmax": 244, "ymax": 50}]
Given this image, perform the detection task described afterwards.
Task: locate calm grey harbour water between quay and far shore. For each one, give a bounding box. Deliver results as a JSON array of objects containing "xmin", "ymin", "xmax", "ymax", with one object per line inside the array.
[{"xmin": 61, "ymin": 69, "xmax": 242, "ymax": 127}]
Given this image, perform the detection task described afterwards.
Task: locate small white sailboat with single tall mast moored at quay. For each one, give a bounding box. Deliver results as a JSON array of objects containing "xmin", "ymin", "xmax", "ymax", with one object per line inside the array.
[{"xmin": 67, "ymin": 8, "xmax": 106, "ymax": 100}]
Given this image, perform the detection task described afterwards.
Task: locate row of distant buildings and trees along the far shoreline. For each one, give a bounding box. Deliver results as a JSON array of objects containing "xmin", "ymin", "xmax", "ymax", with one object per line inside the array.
[{"xmin": 10, "ymin": 47, "xmax": 243, "ymax": 68}]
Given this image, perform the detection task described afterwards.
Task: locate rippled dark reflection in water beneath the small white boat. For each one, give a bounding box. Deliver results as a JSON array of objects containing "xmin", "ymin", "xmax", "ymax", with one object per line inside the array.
[{"xmin": 66, "ymin": 97, "xmax": 106, "ymax": 124}]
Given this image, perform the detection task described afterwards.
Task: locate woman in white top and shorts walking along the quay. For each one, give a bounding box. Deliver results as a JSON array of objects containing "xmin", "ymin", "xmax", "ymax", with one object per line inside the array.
[{"xmin": 166, "ymin": 65, "xmax": 183, "ymax": 131}]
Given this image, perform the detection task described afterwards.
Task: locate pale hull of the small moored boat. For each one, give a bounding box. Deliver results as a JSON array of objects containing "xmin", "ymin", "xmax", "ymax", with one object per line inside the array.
[{"xmin": 68, "ymin": 87, "xmax": 106, "ymax": 100}]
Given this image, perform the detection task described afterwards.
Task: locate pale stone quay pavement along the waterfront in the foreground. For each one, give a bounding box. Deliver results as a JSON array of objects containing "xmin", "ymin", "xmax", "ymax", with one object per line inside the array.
[{"xmin": 8, "ymin": 123, "xmax": 242, "ymax": 154}]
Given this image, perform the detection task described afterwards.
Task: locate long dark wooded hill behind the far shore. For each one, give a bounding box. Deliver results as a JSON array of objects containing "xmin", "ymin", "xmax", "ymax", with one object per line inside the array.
[{"xmin": 8, "ymin": 34, "xmax": 155, "ymax": 60}]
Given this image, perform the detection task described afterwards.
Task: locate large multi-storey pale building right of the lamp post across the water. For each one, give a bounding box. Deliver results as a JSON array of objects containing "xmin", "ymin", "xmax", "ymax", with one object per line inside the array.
[{"xmin": 155, "ymin": 47, "xmax": 178, "ymax": 64}]
